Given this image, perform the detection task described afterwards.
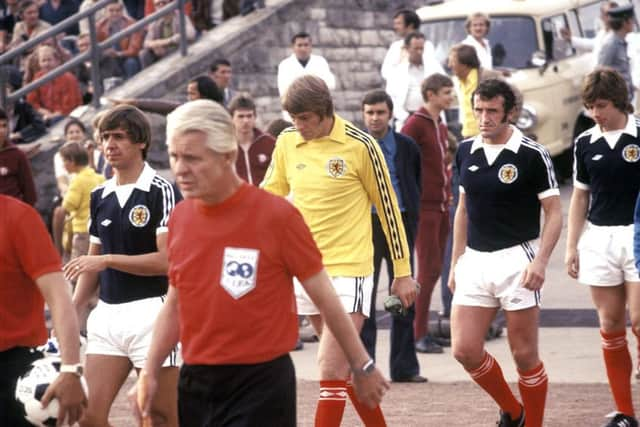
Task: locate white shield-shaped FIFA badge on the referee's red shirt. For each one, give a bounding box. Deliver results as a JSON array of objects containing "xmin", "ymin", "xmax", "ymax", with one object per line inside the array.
[{"xmin": 220, "ymin": 248, "xmax": 260, "ymax": 299}]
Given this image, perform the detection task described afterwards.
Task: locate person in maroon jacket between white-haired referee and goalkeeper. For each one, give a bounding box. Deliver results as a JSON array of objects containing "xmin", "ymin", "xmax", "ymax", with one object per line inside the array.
[{"xmin": 228, "ymin": 93, "xmax": 276, "ymax": 185}]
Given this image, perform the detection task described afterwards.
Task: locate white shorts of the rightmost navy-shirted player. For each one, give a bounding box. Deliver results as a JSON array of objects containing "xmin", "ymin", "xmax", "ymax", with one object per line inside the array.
[{"xmin": 578, "ymin": 223, "xmax": 640, "ymax": 286}]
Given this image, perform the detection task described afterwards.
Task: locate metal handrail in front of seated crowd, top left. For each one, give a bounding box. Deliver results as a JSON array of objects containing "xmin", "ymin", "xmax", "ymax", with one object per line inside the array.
[{"xmin": 0, "ymin": 0, "xmax": 187, "ymax": 108}]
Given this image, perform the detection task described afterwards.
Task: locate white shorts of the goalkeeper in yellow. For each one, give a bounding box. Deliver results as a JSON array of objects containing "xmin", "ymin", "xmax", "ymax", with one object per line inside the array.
[{"xmin": 293, "ymin": 275, "xmax": 373, "ymax": 317}]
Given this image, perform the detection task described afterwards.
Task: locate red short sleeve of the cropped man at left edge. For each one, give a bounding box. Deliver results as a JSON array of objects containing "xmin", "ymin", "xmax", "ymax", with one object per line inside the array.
[{"xmin": 13, "ymin": 203, "xmax": 62, "ymax": 281}]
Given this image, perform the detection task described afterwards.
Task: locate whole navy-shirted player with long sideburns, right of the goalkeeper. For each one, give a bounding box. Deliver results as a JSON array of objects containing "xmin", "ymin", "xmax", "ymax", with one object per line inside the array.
[{"xmin": 449, "ymin": 79, "xmax": 562, "ymax": 427}]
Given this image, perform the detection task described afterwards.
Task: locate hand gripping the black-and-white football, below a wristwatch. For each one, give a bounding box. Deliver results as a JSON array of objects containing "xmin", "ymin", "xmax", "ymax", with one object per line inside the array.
[{"xmin": 40, "ymin": 372, "xmax": 87, "ymax": 426}]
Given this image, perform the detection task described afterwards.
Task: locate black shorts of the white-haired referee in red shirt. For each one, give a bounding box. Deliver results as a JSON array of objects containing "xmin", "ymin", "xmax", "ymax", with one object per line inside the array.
[{"xmin": 178, "ymin": 354, "xmax": 296, "ymax": 427}]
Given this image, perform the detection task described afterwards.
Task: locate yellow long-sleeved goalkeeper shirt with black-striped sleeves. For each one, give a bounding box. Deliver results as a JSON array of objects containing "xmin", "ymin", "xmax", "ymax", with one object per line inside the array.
[{"xmin": 261, "ymin": 115, "xmax": 411, "ymax": 277}]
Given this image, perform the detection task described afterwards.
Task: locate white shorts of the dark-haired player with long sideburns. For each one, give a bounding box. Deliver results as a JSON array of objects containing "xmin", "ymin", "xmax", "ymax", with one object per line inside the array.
[{"xmin": 452, "ymin": 240, "xmax": 542, "ymax": 311}]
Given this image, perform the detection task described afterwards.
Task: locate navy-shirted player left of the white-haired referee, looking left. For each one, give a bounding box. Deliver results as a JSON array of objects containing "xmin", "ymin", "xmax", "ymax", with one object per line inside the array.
[{"xmin": 64, "ymin": 105, "xmax": 180, "ymax": 426}]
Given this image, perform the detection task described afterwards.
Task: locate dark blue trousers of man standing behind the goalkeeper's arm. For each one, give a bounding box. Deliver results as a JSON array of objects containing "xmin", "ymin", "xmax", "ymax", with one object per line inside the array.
[{"xmin": 360, "ymin": 213, "xmax": 420, "ymax": 381}]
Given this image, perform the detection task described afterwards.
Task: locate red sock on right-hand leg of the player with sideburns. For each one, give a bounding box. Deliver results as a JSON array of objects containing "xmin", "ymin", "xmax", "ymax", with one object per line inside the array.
[{"xmin": 518, "ymin": 362, "xmax": 549, "ymax": 427}]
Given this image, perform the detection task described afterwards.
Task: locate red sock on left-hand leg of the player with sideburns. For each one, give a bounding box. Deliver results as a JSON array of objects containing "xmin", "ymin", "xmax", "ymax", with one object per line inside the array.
[{"xmin": 467, "ymin": 352, "xmax": 529, "ymax": 425}]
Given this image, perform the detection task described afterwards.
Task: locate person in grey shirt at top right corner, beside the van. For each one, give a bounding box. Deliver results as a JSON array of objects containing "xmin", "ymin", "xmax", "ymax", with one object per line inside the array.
[{"xmin": 598, "ymin": 4, "xmax": 636, "ymax": 100}]
